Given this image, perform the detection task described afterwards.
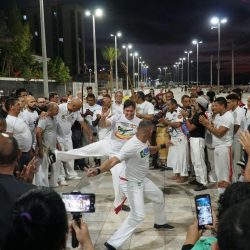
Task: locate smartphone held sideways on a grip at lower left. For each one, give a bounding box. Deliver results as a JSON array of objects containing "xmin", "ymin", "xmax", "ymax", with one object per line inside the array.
[{"xmin": 62, "ymin": 193, "xmax": 95, "ymax": 213}]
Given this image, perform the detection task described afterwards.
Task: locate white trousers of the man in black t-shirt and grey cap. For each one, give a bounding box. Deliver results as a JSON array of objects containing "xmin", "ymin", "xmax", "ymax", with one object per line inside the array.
[{"xmin": 190, "ymin": 137, "xmax": 207, "ymax": 185}]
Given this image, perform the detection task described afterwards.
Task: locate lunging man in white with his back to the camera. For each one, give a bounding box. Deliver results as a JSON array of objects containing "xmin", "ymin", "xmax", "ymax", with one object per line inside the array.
[{"xmin": 88, "ymin": 120, "xmax": 174, "ymax": 250}]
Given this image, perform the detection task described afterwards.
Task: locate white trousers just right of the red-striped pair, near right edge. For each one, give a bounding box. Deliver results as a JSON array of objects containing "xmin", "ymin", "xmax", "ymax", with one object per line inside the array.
[{"xmin": 232, "ymin": 138, "xmax": 243, "ymax": 182}]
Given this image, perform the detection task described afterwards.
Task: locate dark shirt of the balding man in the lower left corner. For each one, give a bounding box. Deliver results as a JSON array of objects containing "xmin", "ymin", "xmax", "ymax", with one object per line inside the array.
[{"xmin": 0, "ymin": 174, "xmax": 35, "ymax": 248}]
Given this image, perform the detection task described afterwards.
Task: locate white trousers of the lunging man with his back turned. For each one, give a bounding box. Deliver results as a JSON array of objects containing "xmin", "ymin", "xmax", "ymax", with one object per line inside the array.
[{"xmin": 108, "ymin": 178, "xmax": 167, "ymax": 248}]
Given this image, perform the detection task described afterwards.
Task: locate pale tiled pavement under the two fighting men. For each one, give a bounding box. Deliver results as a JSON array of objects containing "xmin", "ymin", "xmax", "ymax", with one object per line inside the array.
[{"xmin": 56, "ymin": 167, "xmax": 217, "ymax": 250}]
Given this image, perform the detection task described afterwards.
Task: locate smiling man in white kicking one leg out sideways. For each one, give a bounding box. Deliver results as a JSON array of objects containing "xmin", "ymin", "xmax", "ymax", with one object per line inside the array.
[{"xmin": 56, "ymin": 100, "xmax": 140, "ymax": 208}]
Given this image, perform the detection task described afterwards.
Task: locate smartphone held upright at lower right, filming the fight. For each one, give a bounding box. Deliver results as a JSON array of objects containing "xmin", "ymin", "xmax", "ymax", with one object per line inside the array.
[{"xmin": 195, "ymin": 194, "xmax": 213, "ymax": 229}]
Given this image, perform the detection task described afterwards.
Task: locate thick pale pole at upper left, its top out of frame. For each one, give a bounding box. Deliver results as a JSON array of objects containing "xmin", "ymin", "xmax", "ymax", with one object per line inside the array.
[{"xmin": 39, "ymin": 0, "xmax": 49, "ymax": 97}]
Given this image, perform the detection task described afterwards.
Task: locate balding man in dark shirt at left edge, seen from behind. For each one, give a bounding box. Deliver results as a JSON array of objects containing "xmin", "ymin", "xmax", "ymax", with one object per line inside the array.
[{"xmin": 0, "ymin": 133, "xmax": 35, "ymax": 248}]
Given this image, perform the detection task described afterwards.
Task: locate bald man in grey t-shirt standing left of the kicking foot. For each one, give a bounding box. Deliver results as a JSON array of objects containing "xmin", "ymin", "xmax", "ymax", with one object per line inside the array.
[{"xmin": 35, "ymin": 102, "xmax": 60, "ymax": 187}]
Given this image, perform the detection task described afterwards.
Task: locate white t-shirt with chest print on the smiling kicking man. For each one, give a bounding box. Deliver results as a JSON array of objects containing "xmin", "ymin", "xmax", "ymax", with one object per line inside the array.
[{"xmin": 108, "ymin": 114, "xmax": 141, "ymax": 152}]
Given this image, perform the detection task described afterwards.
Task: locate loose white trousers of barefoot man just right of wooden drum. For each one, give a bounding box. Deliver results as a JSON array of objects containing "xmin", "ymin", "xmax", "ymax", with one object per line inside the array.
[{"xmin": 167, "ymin": 136, "xmax": 189, "ymax": 176}]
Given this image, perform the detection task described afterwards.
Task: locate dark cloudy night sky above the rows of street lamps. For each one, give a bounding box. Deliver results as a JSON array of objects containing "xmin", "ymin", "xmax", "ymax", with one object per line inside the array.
[{"xmin": 84, "ymin": 0, "xmax": 250, "ymax": 83}]
